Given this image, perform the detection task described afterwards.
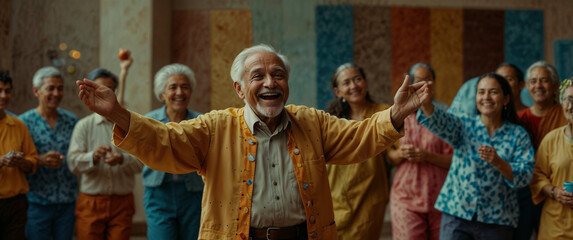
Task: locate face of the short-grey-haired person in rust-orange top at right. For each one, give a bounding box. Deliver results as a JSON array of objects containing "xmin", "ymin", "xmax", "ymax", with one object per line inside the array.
[{"xmin": 527, "ymin": 67, "xmax": 558, "ymax": 104}]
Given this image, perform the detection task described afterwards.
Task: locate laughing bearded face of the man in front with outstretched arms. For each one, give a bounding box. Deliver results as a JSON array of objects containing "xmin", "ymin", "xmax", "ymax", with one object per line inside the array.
[{"xmin": 234, "ymin": 52, "xmax": 289, "ymax": 122}]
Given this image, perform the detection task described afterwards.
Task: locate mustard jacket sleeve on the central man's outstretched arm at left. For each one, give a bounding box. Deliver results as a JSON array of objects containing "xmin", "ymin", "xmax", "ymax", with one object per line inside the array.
[{"xmin": 112, "ymin": 112, "xmax": 210, "ymax": 174}]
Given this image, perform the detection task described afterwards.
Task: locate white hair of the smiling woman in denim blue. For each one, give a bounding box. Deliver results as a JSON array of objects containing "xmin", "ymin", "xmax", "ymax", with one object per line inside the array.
[{"xmin": 153, "ymin": 63, "xmax": 197, "ymax": 102}]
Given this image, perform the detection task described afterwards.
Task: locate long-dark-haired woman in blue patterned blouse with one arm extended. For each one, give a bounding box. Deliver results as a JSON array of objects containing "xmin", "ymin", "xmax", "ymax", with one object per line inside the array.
[{"xmin": 417, "ymin": 73, "xmax": 535, "ymax": 239}]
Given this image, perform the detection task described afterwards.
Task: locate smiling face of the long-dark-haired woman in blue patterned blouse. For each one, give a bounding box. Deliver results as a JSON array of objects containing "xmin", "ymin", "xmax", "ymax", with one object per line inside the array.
[{"xmin": 476, "ymin": 77, "xmax": 509, "ymax": 118}]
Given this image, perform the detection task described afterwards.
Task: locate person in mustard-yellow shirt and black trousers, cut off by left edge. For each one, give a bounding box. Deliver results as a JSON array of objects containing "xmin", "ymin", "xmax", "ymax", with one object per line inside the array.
[{"xmin": 0, "ymin": 72, "xmax": 38, "ymax": 239}]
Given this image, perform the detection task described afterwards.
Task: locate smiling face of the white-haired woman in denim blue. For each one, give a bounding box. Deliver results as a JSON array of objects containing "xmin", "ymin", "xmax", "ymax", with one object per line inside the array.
[{"xmin": 159, "ymin": 74, "xmax": 191, "ymax": 112}]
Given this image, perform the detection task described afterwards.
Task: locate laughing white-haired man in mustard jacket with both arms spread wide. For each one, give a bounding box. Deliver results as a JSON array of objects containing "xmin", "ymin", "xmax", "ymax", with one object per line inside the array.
[{"xmin": 77, "ymin": 45, "xmax": 430, "ymax": 239}]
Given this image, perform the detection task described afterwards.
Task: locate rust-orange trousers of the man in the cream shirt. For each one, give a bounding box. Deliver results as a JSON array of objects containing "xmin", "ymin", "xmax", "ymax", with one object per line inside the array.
[{"xmin": 76, "ymin": 193, "xmax": 135, "ymax": 240}]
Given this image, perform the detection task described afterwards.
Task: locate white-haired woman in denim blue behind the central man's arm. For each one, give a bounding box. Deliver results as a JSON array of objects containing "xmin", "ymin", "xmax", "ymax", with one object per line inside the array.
[{"xmin": 143, "ymin": 63, "xmax": 203, "ymax": 239}]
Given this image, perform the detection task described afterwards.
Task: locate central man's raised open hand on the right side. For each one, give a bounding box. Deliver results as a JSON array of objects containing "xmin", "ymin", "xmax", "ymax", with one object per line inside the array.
[{"xmin": 390, "ymin": 75, "xmax": 431, "ymax": 129}]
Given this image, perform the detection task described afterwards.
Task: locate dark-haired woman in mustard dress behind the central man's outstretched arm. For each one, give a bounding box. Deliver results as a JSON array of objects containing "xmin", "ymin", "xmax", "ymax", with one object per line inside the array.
[{"xmin": 326, "ymin": 63, "xmax": 390, "ymax": 239}]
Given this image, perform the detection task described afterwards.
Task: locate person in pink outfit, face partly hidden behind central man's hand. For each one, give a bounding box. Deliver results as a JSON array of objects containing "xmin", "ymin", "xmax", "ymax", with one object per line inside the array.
[{"xmin": 388, "ymin": 63, "xmax": 453, "ymax": 239}]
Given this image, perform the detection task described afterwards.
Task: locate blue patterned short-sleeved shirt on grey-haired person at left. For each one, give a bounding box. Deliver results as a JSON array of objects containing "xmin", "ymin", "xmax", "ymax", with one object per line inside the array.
[{"xmin": 19, "ymin": 108, "xmax": 78, "ymax": 205}]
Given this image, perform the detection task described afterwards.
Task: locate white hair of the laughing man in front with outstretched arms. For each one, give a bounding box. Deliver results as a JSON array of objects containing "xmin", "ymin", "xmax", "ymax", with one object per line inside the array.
[{"xmin": 231, "ymin": 44, "xmax": 290, "ymax": 87}]
